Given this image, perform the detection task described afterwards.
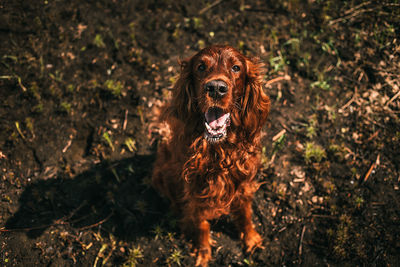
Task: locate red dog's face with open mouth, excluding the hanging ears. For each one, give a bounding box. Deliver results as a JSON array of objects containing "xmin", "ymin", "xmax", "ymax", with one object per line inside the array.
[{"xmin": 190, "ymin": 46, "xmax": 247, "ymax": 143}]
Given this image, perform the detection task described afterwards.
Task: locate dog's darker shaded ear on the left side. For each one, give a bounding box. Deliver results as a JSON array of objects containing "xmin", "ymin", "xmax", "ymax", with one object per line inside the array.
[{"xmin": 161, "ymin": 59, "xmax": 195, "ymax": 121}]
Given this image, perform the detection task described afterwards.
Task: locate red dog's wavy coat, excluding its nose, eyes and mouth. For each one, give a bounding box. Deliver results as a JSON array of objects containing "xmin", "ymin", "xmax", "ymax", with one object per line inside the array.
[{"xmin": 153, "ymin": 46, "xmax": 270, "ymax": 266}]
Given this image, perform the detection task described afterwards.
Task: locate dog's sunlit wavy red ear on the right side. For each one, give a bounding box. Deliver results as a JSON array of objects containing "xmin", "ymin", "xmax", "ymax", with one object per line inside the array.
[{"xmin": 241, "ymin": 58, "xmax": 270, "ymax": 140}]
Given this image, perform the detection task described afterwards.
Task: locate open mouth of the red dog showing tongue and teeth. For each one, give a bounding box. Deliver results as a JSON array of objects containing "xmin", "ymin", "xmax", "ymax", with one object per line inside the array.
[{"xmin": 204, "ymin": 107, "xmax": 231, "ymax": 143}]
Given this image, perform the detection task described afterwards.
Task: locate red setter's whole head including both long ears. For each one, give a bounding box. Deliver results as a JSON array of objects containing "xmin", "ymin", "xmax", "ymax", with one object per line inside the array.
[{"xmin": 165, "ymin": 45, "xmax": 269, "ymax": 143}]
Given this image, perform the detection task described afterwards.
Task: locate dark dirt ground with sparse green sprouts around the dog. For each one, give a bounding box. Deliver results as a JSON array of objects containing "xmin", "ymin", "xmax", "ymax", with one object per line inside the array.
[{"xmin": 0, "ymin": 0, "xmax": 400, "ymax": 266}]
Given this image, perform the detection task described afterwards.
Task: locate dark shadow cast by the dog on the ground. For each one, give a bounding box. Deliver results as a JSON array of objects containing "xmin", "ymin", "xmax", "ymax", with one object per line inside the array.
[{"xmin": 6, "ymin": 155, "xmax": 168, "ymax": 241}]
